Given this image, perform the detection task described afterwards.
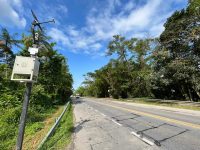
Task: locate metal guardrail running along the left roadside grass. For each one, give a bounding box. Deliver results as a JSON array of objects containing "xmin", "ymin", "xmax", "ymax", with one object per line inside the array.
[{"xmin": 37, "ymin": 101, "xmax": 70, "ymax": 149}]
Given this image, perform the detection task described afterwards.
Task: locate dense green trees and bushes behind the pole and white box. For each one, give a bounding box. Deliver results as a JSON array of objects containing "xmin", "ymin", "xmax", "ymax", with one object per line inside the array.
[{"xmin": 0, "ymin": 29, "xmax": 73, "ymax": 150}]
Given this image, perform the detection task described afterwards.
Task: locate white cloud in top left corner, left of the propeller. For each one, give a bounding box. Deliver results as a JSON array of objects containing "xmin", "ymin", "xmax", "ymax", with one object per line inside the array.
[{"xmin": 0, "ymin": 0, "xmax": 26, "ymax": 28}]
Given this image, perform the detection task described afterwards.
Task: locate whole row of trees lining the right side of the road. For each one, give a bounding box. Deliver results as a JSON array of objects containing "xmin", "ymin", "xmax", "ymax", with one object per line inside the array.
[{"xmin": 76, "ymin": 0, "xmax": 200, "ymax": 101}]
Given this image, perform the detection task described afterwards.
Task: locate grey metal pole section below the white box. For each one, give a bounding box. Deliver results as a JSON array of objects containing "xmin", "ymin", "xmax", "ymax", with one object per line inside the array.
[{"xmin": 16, "ymin": 82, "xmax": 32, "ymax": 150}]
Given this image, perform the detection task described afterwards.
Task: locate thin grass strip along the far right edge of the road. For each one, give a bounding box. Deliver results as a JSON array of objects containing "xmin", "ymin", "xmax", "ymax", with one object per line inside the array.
[{"xmin": 115, "ymin": 98, "xmax": 200, "ymax": 111}]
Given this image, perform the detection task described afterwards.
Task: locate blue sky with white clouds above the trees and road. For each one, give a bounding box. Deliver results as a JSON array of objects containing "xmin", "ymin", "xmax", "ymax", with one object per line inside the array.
[{"xmin": 0, "ymin": 0, "xmax": 187, "ymax": 89}]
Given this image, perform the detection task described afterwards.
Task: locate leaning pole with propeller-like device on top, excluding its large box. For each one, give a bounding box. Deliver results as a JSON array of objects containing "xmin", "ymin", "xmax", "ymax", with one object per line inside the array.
[{"xmin": 12, "ymin": 10, "xmax": 55, "ymax": 150}]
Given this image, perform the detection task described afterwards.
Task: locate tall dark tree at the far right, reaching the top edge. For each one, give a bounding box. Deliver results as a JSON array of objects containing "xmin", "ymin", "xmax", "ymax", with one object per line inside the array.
[{"xmin": 153, "ymin": 0, "xmax": 200, "ymax": 100}]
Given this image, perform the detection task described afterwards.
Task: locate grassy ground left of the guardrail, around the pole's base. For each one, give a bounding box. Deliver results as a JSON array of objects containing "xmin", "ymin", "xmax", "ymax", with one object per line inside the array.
[{"xmin": 0, "ymin": 106, "xmax": 63, "ymax": 150}]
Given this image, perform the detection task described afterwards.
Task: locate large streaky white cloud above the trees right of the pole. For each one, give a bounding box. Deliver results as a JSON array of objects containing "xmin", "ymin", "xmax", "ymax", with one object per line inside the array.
[{"xmin": 47, "ymin": 0, "xmax": 185, "ymax": 54}]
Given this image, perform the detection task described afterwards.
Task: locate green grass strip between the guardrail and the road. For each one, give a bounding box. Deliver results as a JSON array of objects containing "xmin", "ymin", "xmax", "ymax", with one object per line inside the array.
[{"xmin": 39, "ymin": 104, "xmax": 73, "ymax": 150}]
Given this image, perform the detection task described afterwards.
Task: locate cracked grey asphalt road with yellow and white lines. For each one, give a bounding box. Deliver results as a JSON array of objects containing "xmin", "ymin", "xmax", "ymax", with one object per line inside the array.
[{"xmin": 73, "ymin": 98, "xmax": 200, "ymax": 150}]
